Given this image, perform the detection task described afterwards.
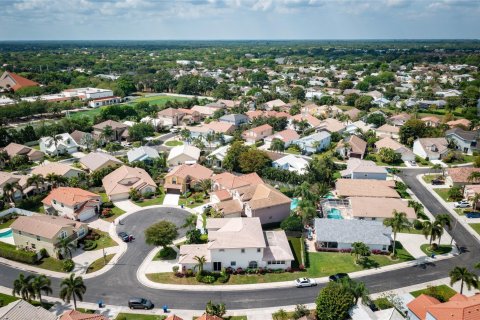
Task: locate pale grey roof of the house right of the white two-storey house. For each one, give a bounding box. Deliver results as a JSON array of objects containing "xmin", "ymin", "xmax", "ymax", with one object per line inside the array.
[{"xmin": 315, "ymin": 218, "xmax": 392, "ymax": 245}]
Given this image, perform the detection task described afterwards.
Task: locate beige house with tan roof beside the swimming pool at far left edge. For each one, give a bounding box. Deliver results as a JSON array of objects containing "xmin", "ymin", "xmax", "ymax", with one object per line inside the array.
[{"xmin": 10, "ymin": 214, "xmax": 88, "ymax": 257}]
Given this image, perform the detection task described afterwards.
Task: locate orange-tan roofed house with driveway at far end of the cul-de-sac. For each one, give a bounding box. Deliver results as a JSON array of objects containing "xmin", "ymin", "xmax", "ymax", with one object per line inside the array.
[{"xmin": 164, "ymin": 163, "xmax": 213, "ymax": 194}]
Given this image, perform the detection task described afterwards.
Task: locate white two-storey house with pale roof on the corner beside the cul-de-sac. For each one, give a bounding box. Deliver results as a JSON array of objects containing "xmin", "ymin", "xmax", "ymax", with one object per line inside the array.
[{"xmin": 178, "ymin": 218, "xmax": 294, "ymax": 271}]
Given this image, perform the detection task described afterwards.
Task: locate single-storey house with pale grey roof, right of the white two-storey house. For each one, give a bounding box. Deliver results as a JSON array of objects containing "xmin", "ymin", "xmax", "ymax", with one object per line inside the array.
[{"xmin": 315, "ymin": 218, "xmax": 392, "ymax": 252}]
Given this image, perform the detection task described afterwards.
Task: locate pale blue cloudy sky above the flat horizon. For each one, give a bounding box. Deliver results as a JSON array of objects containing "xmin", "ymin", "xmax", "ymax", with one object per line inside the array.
[{"xmin": 0, "ymin": 0, "xmax": 480, "ymax": 40}]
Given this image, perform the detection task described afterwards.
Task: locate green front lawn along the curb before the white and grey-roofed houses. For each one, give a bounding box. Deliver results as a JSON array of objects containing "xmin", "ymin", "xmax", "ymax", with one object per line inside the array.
[{"xmin": 147, "ymin": 251, "xmax": 413, "ymax": 285}]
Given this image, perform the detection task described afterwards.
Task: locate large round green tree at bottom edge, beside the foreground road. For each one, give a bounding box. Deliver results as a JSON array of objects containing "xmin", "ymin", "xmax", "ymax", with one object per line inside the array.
[{"xmin": 315, "ymin": 282, "xmax": 354, "ymax": 320}]
